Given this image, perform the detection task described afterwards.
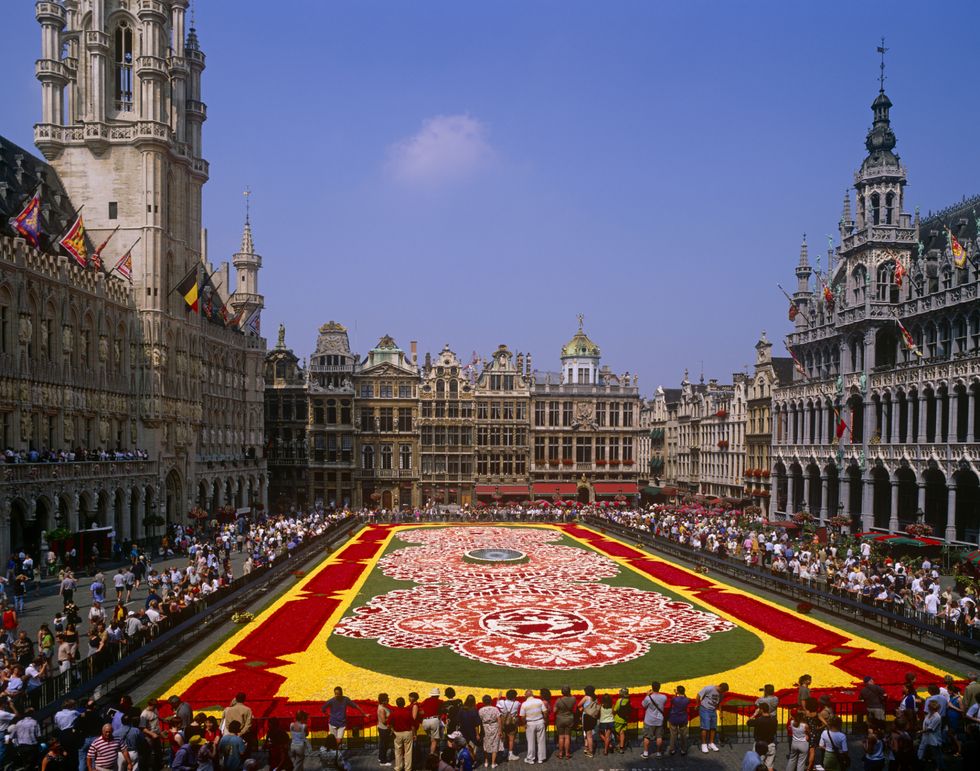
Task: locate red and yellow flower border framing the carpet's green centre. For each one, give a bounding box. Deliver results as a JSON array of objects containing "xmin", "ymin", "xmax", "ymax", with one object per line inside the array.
[{"xmin": 160, "ymin": 523, "xmax": 942, "ymax": 717}]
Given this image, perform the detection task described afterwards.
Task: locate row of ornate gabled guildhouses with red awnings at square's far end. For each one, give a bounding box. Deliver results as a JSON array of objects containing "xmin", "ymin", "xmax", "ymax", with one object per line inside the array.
[{"xmin": 265, "ymin": 322, "xmax": 646, "ymax": 510}]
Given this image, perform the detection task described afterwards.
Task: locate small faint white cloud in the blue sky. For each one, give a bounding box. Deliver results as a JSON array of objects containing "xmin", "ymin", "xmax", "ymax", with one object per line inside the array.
[{"xmin": 388, "ymin": 115, "xmax": 494, "ymax": 185}]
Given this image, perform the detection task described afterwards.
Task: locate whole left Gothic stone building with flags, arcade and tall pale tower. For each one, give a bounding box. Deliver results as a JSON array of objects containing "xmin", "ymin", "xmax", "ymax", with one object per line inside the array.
[{"xmin": 0, "ymin": 0, "xmax": 266, "ymax": 560}]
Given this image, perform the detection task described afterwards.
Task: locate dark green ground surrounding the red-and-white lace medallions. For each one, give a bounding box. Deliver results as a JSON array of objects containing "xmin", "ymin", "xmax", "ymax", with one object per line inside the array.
[{"xmin": 327, "ymin": 536, "xmax": 763, "ymax": 695}]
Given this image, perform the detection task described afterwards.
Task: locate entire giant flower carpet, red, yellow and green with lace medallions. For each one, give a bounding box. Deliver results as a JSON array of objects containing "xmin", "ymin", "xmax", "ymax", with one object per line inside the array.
[{"xmin": 167, "ymin": 524, "xmax": 945, "ymax": 716}]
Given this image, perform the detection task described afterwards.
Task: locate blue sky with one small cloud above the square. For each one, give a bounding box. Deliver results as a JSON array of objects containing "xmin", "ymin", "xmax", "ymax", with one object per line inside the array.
[{"xmin": 0, "ymin": 0, "xmax": 980, "ymax": 395}]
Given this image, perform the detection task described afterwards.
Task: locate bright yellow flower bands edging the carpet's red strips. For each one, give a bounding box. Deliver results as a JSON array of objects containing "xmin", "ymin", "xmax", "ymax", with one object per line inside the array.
[{"xmin": 161, "ymin": 523, "xmax": 952, "ymax": 701}]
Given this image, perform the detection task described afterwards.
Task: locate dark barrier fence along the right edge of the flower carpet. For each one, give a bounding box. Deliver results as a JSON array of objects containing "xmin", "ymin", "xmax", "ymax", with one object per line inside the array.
[{"xmin": 584, "ymin": 517, "xmax": 980, "ymax": 666}]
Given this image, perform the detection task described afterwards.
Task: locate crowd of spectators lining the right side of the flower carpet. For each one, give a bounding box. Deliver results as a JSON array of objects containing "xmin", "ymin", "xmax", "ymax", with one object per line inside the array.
[{"xmin": 591, "ymin": 505, "xmax": 980, "ymax": 638}]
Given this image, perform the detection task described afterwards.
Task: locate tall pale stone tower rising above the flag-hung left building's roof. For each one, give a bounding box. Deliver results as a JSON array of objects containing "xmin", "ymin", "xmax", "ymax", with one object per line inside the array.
[{"xmin": 34, "ymin": 0, "xmax": 208, "ymax": 317}]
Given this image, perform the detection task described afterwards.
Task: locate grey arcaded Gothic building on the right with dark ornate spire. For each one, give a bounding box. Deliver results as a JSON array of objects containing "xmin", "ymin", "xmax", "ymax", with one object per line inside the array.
[{"xmin": 771, "ymin": 81, "xmax": 980, "ymax": 544}]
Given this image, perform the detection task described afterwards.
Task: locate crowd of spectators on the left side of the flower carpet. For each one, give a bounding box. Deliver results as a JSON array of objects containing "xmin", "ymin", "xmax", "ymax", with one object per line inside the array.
[{"xmin": 0, "ymin": 511, "xmax": 344, "ymax": 740}]
